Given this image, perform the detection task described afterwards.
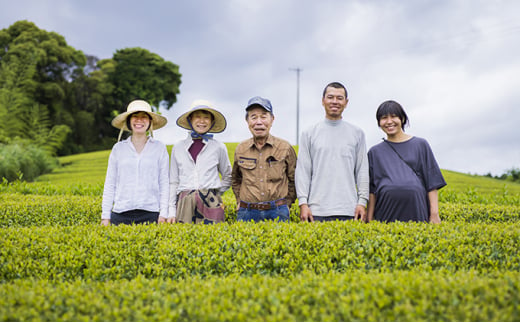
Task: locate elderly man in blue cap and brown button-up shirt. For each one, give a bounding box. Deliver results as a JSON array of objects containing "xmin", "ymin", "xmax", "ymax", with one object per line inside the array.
[{"xmin": 231, "ymin": 96, "xmax": 296, "ymax": 222}]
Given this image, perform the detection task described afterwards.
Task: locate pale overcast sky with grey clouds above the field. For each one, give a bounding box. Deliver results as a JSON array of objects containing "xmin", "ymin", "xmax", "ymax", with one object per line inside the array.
[{"xmin": 0, "ymin": 0, "xmax": 520, "ymax": 175}]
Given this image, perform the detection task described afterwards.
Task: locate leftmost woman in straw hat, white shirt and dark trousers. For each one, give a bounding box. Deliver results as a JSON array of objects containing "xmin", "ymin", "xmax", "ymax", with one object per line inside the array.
[{"xmin": 101, "ymin": 100, "xmax": 169, "ymax": 225}]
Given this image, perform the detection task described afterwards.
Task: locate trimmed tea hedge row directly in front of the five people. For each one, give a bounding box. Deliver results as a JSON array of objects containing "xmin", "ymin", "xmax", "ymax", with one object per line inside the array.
[{"xmin": 0, "ymin": 222, "xmax": 520, "ymax": 282}]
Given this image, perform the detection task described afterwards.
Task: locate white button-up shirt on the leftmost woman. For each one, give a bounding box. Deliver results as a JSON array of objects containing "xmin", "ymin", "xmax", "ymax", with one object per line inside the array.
[{"xmin": 101, "ymin": 137, "xmax": 170, "ymax": 219}]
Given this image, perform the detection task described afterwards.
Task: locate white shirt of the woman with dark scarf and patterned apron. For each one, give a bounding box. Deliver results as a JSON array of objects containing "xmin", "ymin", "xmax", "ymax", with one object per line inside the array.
[{"xmin": 169, "ymin": 135, "xmax": 231, "ymax": 217}]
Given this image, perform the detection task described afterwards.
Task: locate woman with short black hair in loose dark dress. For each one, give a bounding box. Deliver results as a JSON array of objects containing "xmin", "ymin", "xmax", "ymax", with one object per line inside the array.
[{"xmin": 368, "ymin": 101, "xmax": 446, "ymax": 223}]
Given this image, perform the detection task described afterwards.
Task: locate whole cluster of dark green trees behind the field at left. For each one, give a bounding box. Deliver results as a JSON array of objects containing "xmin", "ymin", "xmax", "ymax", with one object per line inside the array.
[{"xmin": 0, "ymin": 20, "xmax": 181, "ymax": 182}]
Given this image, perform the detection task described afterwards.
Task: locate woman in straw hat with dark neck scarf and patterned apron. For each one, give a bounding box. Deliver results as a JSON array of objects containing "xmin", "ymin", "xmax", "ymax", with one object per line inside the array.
[{"xmin": 168, "ymin": 100, "xmax": 231, "ymax": 224}]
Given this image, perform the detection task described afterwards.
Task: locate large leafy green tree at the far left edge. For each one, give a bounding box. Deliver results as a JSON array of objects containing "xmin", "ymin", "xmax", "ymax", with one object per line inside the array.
[{"xmin": 0, "ymin": 20, "xmax": 85, "ymax": 153}]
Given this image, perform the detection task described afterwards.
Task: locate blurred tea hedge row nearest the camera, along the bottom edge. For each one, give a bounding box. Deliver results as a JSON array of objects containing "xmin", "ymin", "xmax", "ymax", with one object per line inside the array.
[{"xmin": 0, "ymin": 270, "xmax": 520, "ymax": 322}]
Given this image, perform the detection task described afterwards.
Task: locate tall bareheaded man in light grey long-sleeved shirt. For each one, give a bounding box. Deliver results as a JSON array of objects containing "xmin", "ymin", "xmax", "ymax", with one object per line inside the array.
[{"xmin": 295, "ymin": 82, "xmax": 369, "ymax": 222}]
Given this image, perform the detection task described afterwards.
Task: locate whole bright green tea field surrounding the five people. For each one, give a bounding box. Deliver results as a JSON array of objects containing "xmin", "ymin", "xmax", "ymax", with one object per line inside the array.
[{"xmin": 0, "ymin": 144, "xmax": 520, "ymax": 321}]
